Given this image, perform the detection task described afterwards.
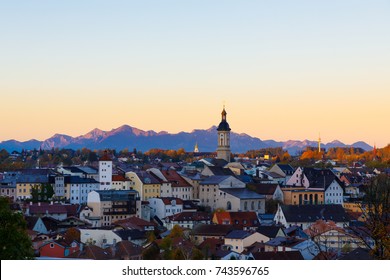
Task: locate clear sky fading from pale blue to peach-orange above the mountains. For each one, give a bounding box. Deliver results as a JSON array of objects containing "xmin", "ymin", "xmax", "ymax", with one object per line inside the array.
[{"xmin": 0, "ymin": 0, "xmax": 390, "ymax": 147}]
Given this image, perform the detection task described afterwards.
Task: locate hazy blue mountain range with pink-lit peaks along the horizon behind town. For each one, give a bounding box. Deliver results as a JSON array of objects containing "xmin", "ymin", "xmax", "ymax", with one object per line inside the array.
[{"xmin": 0, "ymin": 125, "xmax": 373, "ymax": 155}]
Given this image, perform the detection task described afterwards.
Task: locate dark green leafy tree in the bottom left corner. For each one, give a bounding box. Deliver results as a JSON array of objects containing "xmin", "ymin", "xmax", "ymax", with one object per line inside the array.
[{"xmin": 0, "ymin": 197, "xmax": 34, "ymax": 260}]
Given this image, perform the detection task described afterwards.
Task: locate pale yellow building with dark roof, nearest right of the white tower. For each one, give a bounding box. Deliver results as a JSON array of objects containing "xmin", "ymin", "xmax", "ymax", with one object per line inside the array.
[{"xmin": 126, "ymin": 171, "xmax": 161, "ymax": 200}]
